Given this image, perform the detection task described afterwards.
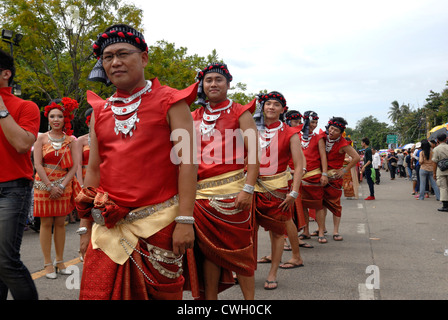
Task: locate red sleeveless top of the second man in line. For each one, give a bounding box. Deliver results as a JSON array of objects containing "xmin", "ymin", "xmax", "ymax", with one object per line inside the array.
[{"xmin": 192, "ymin": 100, "xmax": 255, "ymax": 180}]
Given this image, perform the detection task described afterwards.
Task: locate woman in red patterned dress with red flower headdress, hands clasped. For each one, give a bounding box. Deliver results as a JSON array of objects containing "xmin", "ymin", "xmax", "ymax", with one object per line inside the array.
[{"xmin": 34, "ymin": 98, "xmax": 80, "ymax": 279}]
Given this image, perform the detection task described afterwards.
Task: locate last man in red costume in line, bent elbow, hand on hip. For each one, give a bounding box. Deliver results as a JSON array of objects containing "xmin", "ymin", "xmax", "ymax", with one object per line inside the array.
[{"xmin": 316, "ymin": 117, "xmax": 359, "ymax": 243}]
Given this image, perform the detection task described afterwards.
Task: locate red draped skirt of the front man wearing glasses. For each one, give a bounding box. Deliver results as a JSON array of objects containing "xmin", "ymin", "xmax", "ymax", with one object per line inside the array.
[{"xmin": 79, "ymin": 223, "xmax": 185, "ymax": 300}]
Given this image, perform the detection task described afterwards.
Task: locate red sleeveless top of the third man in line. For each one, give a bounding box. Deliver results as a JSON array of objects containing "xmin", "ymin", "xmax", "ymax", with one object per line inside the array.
[{"xmin": 260, "ymin": 121, "xmax": 297, "ymax": 176}]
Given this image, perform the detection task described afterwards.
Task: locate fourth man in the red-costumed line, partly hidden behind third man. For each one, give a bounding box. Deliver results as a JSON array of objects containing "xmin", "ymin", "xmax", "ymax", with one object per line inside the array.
[{"xmin": 299, "ymin": 111, "xmax": 328, "ymax": 239}]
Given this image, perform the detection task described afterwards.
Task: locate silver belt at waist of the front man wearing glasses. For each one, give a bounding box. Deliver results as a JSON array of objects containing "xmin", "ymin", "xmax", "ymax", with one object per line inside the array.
[{"xmin": 91, "ymin": 195, "xmax": 179, "ymax": 226}]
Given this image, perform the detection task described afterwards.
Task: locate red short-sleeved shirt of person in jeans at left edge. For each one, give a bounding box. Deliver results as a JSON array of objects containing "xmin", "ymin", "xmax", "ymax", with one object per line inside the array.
[{"xmin": 0, "ymin": 87, "xmax": 40, "ymax": 182}]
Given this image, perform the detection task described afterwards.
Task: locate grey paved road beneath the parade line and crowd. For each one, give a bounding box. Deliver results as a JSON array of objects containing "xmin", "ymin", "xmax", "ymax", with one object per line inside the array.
[{"xmin": 11, "ymin": 174, "xmax": 448, "ymax": 300}]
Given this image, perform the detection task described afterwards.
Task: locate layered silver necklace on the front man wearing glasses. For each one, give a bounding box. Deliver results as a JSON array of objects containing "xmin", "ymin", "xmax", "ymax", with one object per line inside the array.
[{"xmin": 104, "ymin": 80, "xmax": 152, "ymax": 137}]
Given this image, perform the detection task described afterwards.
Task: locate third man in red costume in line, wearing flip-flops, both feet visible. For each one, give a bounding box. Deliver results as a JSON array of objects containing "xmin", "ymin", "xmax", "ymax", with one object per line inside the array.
[{"xmin": 254, "ymin": 91, "xmax": 303, "ymax": 290}]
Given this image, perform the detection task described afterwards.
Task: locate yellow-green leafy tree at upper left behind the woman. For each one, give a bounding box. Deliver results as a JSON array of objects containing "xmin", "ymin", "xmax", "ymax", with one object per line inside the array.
[{"xmin": 0, "ymin": 0, "xmax": 142, "ymax": 133}]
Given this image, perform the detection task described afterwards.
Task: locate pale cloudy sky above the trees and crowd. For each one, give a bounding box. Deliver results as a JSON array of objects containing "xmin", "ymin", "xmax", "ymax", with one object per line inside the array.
[{"xmin": 129, "ymin": 0, "xmax": 448, "ymax": 128}]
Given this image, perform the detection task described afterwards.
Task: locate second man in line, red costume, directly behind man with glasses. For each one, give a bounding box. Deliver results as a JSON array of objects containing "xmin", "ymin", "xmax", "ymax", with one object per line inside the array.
[{"xmin": 193, "ymin": 63, "xmax": 259, "ymax": 300}]
